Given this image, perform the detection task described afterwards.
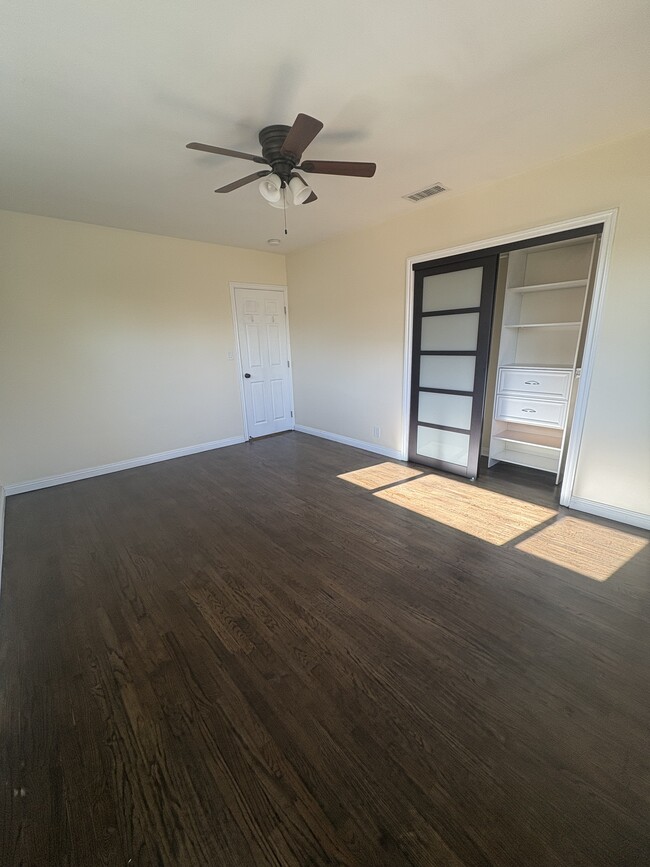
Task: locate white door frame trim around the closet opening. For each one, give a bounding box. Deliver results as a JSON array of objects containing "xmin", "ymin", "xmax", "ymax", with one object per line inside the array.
[{"xmin": 401, "ymin": 208, "xmax": 618, "ymax": 507}]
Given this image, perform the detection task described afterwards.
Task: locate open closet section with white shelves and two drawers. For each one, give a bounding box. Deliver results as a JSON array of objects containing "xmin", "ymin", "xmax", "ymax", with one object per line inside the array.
[{"xmin": 482, "ymin": 232, "xmax": 600, "ymax": 484}]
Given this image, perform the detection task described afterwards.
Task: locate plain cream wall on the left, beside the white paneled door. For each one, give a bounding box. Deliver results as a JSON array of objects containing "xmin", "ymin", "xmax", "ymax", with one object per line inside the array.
[{"xmin": 0, "ymin": 212, "xmax": 286, "ymax": 485}]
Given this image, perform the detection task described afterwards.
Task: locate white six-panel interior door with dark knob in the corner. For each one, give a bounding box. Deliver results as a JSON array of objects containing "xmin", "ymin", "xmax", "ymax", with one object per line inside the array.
[{"xmin": 234, "ymin": 286, "xmax": 293, "ymax": 437}]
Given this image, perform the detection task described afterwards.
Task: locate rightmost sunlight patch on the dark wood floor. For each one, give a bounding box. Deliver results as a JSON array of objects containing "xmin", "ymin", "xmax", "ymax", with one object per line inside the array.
[{"xmin": 515, "ymin": 517, "xmax": 648, "ymax": 581}]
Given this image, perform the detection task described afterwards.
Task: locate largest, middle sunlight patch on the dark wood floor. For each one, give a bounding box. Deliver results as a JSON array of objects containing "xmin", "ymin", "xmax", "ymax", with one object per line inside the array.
[{"xmin": 373, "ymin": 474, "xmax": 557, "ymax": 545}]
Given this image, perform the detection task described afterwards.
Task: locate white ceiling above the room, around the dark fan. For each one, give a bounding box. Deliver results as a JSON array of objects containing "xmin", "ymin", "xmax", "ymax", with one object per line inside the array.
[{"xmin": 0, "ymin": 0, "xmax": 650, "ymax": 252}]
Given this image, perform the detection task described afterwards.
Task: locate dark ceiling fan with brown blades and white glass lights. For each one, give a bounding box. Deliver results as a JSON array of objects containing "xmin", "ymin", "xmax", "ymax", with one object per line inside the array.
[{"xmin": 187, "ymin": 114, "xmax": 377, "ymax": 208}]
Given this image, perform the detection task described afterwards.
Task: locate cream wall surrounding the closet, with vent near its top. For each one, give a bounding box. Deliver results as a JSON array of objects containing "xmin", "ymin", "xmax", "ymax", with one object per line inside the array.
[{"xmin": 287, "ymin": 134, "xmax": 650, "ymax": 514}]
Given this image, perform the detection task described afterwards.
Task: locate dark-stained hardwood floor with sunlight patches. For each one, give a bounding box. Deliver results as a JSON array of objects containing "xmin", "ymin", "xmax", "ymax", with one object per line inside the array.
[{"xmin": 0, "ymin": 433, "xmax": 650, "ymax": 867}]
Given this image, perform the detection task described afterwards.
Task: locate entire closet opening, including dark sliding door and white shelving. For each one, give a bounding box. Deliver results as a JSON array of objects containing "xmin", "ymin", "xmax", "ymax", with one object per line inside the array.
[{"xmin": 405, "ymin": 223, "xmax": 604, "ymax": 500}]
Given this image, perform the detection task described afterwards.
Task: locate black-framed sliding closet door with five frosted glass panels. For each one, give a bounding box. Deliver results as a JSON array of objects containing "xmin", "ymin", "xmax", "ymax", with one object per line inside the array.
[{"xmin": 409, "ymin": 256, "xmax": 498, "ymax": 478}]
